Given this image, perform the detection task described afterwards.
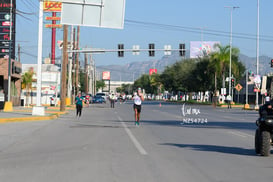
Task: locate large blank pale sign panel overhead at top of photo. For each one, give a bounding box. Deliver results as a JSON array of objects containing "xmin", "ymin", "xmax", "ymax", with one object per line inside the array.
[{"xmin": 61, "ymin": 0, "xmax": 125, "ymax": 29}]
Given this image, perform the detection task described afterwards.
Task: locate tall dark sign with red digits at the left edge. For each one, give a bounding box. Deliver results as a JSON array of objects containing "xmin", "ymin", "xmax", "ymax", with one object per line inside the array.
[{"xmin": 0, "ymin": 0, "xmax": 16, "ymax": 59}]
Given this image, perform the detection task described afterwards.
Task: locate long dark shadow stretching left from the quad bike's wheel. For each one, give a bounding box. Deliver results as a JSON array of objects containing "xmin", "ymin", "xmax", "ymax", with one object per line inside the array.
[{"xmin": 160, "ymin": 143, "xmax": 256, "ymax": 156}]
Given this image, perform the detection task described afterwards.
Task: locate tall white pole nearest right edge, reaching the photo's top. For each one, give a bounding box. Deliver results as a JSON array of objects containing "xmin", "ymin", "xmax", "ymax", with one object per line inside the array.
[{"xmin": 255, "ymin": 0, "xmax": 260, "ymax": 109}]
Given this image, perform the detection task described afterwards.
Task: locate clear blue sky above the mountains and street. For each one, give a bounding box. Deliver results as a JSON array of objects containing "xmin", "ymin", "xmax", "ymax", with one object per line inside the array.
[{"xmin": 16, "ymin": 0, "xmax": 273, "ymax": 65}]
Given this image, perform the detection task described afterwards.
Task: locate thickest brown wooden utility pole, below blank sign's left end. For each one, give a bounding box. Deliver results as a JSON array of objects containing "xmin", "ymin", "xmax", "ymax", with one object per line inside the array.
[{"xmin": 60, "ymin": 25, "xmax": 68, "ymax": 111}]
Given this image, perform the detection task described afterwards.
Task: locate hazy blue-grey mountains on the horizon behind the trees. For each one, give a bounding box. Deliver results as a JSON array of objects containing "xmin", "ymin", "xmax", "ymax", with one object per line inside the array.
[{"xmin": 97, "ymin": 52, "xmax": 273, "ymax": 81}]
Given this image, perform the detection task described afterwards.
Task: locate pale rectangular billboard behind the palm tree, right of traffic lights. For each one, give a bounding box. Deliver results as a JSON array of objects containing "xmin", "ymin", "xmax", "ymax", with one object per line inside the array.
[{"xmin": 190, "ymin": 41, "xmax": 220, "ymax": 58}]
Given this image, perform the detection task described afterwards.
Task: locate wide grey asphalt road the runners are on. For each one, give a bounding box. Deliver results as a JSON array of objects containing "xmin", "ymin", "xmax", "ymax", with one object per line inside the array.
[{"xmin": 0, "ymin": 102, "xmax": 273, "ymax": 182}]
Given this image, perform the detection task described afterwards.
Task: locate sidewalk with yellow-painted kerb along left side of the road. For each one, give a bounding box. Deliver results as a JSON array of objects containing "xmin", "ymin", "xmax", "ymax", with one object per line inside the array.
[{"xmin": 0, "ymin": 106, "xmax": 74, "ymax": 123}]
